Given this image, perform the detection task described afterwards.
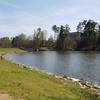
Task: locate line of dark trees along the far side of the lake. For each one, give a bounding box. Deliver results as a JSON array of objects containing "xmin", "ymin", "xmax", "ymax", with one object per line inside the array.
[{"xmin": 0, "ymin": 20, "xmax": 100, "ymax": 51}]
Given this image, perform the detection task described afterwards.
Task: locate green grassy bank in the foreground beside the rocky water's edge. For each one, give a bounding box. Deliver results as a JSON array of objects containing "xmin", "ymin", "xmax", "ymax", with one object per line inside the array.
[{"xmin": 0, "ymin": 49, "xmax": 98, "ymax": 100}]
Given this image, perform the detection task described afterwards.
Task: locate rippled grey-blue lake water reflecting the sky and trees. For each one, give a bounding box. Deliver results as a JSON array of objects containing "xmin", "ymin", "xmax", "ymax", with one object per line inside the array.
[{"xmin": 7, "ymin": 51, "xmax": 100, "ymax": 83}]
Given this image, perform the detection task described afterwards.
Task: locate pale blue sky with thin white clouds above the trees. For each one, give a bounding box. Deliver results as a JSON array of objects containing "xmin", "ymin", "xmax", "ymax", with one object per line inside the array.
[{"xmin": 0, "ymin": 0, "xmax": 100, "ymax": 37}]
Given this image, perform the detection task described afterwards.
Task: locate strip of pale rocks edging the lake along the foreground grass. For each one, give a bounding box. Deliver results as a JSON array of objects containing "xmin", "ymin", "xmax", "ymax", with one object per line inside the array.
[{"xmin": 3, "ymin": 53, "xmax": 100, "ymax": 95}]
